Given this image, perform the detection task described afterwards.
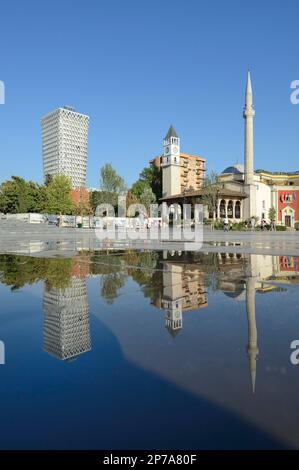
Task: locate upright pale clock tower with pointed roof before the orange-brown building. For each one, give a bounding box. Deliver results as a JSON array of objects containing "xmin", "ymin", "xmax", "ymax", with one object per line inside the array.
[{"xmin": 162, "ymin": 126, "xmax": 181, "ymax": 197}]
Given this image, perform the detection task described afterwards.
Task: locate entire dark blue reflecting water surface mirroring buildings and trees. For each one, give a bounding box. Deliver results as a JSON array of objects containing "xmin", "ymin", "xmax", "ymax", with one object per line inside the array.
[{"xmin": 0, "ymin": 250, "xmax": 299, "ymax": 449}]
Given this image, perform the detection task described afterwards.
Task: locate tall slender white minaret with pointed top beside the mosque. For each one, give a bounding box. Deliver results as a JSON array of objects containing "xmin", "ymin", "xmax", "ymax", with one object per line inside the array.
[{"xmin": 243, "ymin": 70, "xmax": 256, "ymax": 218}]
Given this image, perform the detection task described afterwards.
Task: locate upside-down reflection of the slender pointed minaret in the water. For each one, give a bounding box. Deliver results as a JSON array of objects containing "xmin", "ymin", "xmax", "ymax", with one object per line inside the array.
[{"xmin": 246, "ymin": 276, "xmax": 259, "ymax": 393}]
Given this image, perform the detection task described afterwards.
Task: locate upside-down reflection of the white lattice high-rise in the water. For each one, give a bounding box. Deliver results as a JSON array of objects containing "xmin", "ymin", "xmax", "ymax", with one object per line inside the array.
[{"xmin": 44, "ymin": 277, "xmax": 91, "ymax": 360}]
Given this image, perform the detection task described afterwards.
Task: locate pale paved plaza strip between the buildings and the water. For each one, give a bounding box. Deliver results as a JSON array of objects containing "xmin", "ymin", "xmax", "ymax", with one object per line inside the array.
[{"xmin": 0, "ymin": 220, "xmax": 299, "ymax": 257}]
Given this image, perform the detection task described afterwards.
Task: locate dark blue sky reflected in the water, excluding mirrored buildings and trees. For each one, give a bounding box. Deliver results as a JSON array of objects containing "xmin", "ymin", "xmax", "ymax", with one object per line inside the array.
[{"xmin": 0, "ymin": 260, "xmax": 299, "ymax": 448}]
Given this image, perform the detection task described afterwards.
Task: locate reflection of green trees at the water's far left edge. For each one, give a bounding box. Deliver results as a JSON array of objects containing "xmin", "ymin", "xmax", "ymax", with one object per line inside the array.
[{"xmin": 0, "ymin": 255, "xmax": 74, "ymax": 290}]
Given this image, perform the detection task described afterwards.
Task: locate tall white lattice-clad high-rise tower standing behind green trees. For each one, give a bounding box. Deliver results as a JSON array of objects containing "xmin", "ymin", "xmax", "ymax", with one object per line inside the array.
[{"xmin": 41, "ymin": 106, "xmax": 89, "ymax": 188}]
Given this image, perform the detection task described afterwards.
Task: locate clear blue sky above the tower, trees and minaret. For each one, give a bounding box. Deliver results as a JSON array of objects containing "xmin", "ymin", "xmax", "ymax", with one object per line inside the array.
[{"xmin": 0, "ymin": 0, "xmax": 299, "ymax": 187}]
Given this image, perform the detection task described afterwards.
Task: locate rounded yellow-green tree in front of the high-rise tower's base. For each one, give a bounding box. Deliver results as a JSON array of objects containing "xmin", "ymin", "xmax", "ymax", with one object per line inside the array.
[{"xmin": 46, "ymin": 175, "xmax": 74, "ymax": 220}]
